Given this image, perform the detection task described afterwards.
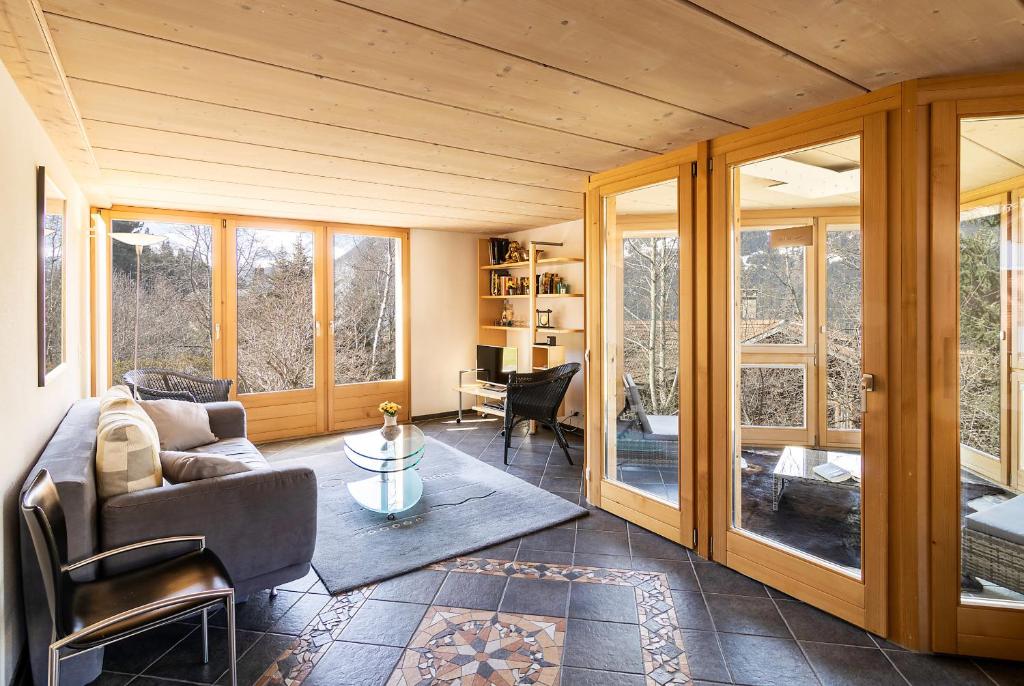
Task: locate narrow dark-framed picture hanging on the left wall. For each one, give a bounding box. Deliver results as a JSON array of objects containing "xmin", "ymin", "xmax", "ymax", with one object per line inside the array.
[{"xmin": 36, "ymin": 166, "xmax": 68, "ymax": 388}]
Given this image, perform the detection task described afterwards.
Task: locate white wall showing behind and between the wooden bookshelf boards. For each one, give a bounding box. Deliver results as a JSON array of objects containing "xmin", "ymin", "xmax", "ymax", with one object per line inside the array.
[{"xmin": 506, "ymin": 219, "xmax": 587, "ymax": 427}]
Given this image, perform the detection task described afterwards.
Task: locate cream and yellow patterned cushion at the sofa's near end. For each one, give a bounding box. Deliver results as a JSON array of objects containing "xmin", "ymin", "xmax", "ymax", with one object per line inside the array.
[{"xmin": 96, "ymin": 386, "xmax": 164, "ymax": 499}]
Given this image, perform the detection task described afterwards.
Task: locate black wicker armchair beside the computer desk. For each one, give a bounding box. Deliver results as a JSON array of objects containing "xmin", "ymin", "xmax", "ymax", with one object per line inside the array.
[{"xmin": 505, "ymin": 362, "xmax": 580, "ymax": 465}]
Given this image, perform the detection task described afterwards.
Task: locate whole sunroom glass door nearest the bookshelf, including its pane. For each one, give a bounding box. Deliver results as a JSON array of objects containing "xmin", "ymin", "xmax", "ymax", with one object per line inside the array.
[{"xmin": 592, "ymin": 164, "xmax": 695, "ymax": 546}]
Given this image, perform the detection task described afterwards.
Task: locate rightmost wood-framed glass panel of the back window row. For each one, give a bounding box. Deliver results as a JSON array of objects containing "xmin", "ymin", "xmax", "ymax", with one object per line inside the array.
[{"xmin": 328, "ymin": 226, "xmax": 410, "ymax": 431}]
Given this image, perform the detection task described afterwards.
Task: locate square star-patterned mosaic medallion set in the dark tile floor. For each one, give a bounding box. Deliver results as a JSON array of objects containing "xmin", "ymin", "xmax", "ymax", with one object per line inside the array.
[{"xmin": 388, "ymin": 607, "xmax": 565, "ymax": 686}]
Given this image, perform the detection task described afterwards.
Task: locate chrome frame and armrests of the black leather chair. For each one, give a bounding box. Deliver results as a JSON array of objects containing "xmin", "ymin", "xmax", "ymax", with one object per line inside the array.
[{"xmin": 47, "ymin": 535, "xmax": 238, "ymax": 686}]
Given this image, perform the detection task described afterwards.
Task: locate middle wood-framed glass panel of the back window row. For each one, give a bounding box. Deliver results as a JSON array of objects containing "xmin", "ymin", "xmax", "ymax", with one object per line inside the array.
[{"xmin": 225, "ymin": 219, "xmax": 327, "ymax": 441}]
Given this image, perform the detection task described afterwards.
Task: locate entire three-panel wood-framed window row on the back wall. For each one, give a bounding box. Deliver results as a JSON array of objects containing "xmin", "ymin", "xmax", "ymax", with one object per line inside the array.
[{"xmin": 106, "ymin": 210, "xmax": 410, "ymax": 440}]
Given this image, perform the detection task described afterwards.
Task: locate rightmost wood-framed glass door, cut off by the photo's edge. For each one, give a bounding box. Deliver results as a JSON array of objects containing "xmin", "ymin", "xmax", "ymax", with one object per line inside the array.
[{"xmin": 932, "ymin": 97, "xmax": 1024, "ymax": 658}]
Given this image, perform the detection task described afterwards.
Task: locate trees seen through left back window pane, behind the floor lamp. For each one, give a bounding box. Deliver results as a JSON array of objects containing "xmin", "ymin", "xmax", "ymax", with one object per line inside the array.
[{"xmin": 111, "ymin": 219, "xmax": 213, "ymax": 382}]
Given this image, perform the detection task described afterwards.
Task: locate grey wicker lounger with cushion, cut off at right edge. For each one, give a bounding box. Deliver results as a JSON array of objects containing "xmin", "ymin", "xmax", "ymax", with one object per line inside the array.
[{"xmin": 963, "ymin": 496, "xmax": 1024, "ymax": 593}]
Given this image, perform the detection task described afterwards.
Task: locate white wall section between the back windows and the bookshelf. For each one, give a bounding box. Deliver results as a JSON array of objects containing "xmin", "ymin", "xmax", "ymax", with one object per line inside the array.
[{"xmin": 409, "ymin": 228, "xmax": 480, "ymax": 417}]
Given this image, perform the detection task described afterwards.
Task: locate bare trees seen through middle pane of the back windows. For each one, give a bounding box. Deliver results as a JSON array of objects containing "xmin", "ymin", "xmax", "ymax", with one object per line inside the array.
[{"xmin": 236, "ymin": 228, "xmax": 315, "ymax": 393}]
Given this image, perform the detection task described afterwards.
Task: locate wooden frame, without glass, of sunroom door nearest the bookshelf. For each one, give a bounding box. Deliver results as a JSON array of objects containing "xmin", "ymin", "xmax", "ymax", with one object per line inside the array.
[{"xmin": 585, "ymin": 146, "xmax": 698, "ymax": 548}]
